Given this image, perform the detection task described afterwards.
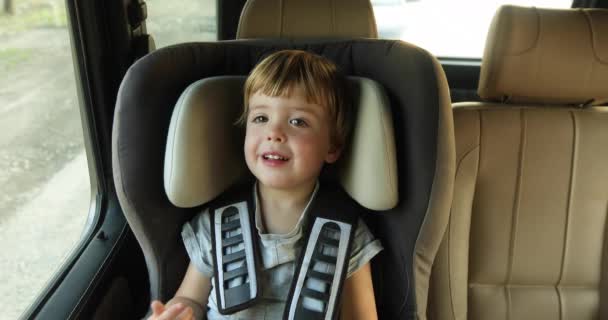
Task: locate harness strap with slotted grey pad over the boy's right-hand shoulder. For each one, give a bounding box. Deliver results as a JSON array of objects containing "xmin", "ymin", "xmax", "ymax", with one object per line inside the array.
[{"xmin": 283, "ymin": 185, "xmax": 362, "ymax": 320}]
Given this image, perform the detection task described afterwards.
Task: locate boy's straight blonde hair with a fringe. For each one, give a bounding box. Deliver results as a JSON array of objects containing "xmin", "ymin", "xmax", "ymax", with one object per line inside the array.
[{"xmin": 238, "ymin": 50, "xmax": 351, "ymax": 147}]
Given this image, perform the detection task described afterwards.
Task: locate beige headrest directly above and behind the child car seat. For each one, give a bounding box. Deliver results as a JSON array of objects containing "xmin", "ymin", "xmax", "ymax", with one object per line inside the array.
[{"xmin": 236, "ymin": 0, "xmax": 378, "ymax": 39}]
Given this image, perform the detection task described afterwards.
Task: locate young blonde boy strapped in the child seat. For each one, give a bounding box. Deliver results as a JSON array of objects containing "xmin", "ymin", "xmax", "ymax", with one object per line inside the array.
[{"xmin": 149, "ymin": 50, "xmax": 382, "ymax": 320}]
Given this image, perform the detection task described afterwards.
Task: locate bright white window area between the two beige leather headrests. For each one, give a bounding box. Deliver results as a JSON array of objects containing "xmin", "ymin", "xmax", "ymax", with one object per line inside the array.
[{"xmin": 372, "ymin": 0, "xmax": 572, "ymax": 58}]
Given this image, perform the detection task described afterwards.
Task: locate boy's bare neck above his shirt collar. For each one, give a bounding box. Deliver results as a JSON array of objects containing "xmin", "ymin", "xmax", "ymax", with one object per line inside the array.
[{"xmin": 258, "ymin": 181, "xmax": 316, "ymax": 234}]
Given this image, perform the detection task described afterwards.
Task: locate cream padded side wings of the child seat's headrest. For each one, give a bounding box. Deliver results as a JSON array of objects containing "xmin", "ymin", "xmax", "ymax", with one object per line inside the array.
[{"xmin": 164, "ymin": 76, "xmax": 398, "ymax": 210}]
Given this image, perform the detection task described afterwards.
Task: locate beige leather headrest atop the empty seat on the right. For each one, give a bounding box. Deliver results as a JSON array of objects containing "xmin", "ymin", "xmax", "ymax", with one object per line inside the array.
[{"xmin": 478, "ymin": 6, "xmax": 608, "ymax": 105}]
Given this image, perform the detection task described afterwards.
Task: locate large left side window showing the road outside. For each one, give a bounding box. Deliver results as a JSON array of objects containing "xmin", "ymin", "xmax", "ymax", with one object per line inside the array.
[{"xmin": 0, "ymin": 0, "xmax": 91, "ymax": 319}]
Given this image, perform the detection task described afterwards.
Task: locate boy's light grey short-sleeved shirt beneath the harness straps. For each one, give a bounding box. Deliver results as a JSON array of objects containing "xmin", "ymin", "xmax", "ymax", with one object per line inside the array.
[{"xmin": 182, "ymin": 184, "xmax": 382, "ymax": 320}]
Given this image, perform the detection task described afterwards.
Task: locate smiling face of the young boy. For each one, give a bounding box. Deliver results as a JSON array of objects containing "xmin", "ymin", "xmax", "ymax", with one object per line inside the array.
[{"xmin": 245, "ymin": 88, "xmax": 340, "ymax": 190}]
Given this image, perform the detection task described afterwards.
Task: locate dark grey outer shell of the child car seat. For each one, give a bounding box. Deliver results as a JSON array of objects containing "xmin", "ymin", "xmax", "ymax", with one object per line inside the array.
[{"xmin": 113, "ymin": 0, "xmax": 454, "ymax": 319}]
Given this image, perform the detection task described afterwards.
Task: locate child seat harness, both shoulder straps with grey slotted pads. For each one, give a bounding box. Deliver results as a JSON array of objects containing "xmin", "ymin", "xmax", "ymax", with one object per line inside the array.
[{"xmin": 209, "ymin": 184, "xmax": 362, "ymax": 320}]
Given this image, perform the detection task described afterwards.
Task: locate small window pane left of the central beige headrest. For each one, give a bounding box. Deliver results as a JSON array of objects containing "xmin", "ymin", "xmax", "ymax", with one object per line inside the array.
[{"xmin": 146, "ymin": 0, "xmax": 217, "ymax": 48}]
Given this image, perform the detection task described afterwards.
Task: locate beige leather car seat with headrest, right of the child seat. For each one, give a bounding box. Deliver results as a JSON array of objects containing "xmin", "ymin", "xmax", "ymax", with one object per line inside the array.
[{"xmin": 429, "ymin": 6, "xmax": 608, "ymax": 320}]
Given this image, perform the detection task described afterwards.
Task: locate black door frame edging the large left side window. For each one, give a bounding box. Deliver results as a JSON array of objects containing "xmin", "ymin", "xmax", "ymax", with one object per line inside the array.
[{"xmin": 22, "ymin": 0, "xmax": 130, "ymax": 319}]
